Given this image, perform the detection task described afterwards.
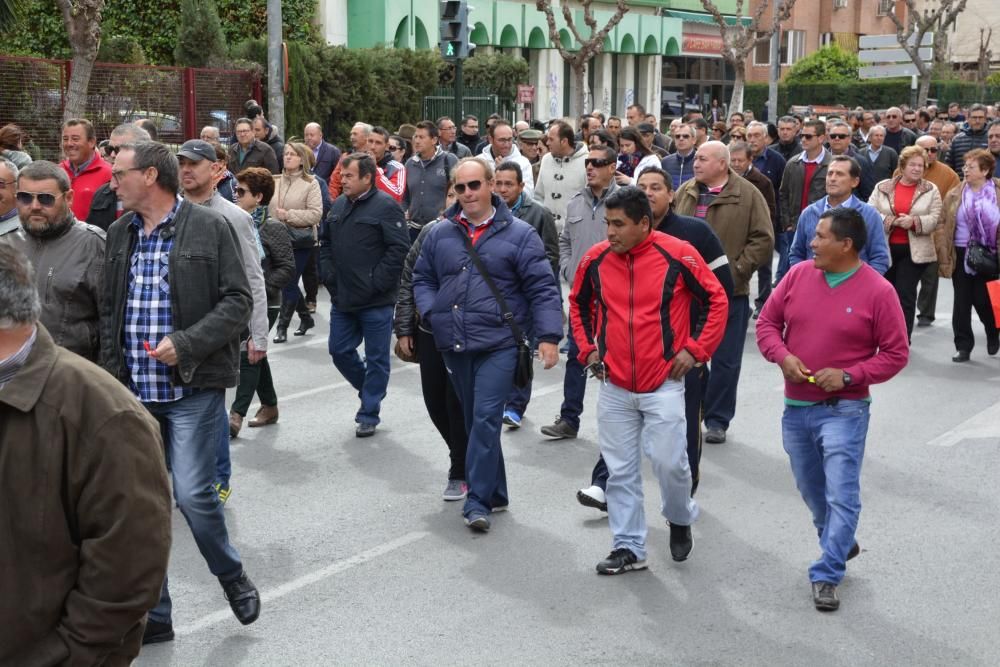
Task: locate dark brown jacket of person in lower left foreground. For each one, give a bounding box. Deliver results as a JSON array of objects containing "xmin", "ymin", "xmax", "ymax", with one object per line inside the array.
[{"xmin": 0, "ymin": 324, "xmax": 170, "ymax": 667}]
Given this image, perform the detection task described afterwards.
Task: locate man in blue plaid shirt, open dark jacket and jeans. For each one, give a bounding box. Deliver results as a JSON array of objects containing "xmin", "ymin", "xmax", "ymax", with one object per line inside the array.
[{"xmin": 101, "ymin": 142, "xmax": 260, "ymax": 643}]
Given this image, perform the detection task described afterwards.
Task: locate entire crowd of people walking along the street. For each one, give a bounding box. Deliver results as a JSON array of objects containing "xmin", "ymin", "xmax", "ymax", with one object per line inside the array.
[{"xmin": 0, "ymin": 95, "xmax": 1000, "ymax": 663}]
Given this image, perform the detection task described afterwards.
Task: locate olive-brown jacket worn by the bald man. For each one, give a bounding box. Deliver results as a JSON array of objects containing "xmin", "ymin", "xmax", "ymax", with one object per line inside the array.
[{"xmin": 674, "ymin": 169, "xmax": 774, "ymax": 296}]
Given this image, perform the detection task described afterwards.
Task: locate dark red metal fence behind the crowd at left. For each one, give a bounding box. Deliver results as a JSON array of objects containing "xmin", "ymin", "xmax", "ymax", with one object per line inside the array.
[{"xmin": 0, "ymin": 56, "xmax": 261, "ymax": 160}]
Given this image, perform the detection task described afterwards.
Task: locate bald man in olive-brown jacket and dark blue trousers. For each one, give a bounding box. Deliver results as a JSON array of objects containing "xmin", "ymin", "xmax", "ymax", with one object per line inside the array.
[{"xmin": 674, "ymin": 141, "xmax": 774, "ymax": 444}]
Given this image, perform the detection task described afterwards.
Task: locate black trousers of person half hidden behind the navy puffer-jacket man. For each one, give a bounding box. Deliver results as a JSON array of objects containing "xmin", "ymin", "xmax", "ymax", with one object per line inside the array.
[{"xmin": 415, "ymin": 329, "xmax": 469, "ymax": 480}]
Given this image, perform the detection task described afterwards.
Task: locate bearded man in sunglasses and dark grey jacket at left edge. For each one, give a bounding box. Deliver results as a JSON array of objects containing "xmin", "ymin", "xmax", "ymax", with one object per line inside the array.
[{"xmin": 11, "ymin": 160, "xmax": 104, "ymax": 362}]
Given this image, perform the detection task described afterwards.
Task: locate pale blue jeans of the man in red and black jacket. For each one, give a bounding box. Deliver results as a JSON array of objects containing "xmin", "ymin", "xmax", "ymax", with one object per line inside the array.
[{"xmin": 597, "ymin": 380, "xmax": 698, "ymax": 559}]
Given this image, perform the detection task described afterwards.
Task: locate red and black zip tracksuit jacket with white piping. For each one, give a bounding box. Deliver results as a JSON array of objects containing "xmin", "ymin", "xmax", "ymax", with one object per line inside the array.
[{"xmin": 570, "ymin": 232, "xmax": 729, "ymax": 393}]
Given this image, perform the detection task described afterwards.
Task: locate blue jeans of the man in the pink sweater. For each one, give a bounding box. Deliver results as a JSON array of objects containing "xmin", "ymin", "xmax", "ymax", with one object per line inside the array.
[{"xmin": 781, "ymin": 400, "xmax": 870, "ymax": 584}]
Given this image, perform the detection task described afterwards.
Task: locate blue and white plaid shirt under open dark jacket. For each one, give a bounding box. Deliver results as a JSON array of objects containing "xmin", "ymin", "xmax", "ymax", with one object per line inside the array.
[{"xmin": 123, "ymin": 197, "xmax": 194, "ymax": 403}]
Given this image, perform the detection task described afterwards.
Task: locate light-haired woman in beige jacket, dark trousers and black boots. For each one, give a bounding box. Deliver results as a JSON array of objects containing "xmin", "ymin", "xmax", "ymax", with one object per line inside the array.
[{"xmin": 268, "ymin": 141, "xmax": 323, "ymax": 343}]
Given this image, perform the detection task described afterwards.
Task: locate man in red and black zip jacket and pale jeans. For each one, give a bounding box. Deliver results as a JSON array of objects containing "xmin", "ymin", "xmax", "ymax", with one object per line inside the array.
[{"xmin": 570, "ymin": 186, "xmax": 728, "ymax": 574}]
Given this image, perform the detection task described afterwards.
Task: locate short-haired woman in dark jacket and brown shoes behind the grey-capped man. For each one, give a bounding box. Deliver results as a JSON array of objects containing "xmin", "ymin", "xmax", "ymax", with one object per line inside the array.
[{"xmin": 229, "ymin": 167, "xmax": 295, "ymax": 438}]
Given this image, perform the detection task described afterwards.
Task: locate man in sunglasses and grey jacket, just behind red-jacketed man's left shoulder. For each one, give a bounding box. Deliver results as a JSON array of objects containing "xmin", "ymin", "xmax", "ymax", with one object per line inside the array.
[{"xmin": 541, "ymin": 146, "xmax": 620, "ymax": 440}]
